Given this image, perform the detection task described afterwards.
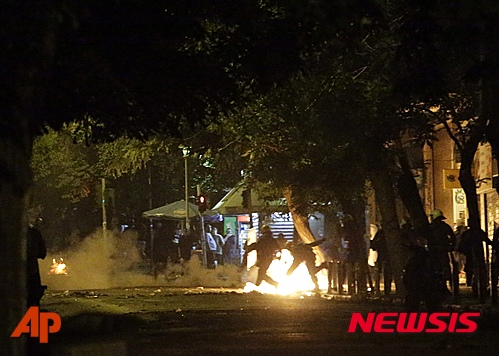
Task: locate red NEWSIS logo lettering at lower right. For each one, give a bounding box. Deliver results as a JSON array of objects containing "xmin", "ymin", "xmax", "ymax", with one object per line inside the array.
[{"xmin": 348, "ymin": 312, "xmax": 480, "ymax": 333}]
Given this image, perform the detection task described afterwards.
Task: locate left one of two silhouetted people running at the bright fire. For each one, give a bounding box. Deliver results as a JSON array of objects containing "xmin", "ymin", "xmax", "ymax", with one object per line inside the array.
[{"xmin": 246, "ymin": 225, "xmax": 280, "ymax": 287}]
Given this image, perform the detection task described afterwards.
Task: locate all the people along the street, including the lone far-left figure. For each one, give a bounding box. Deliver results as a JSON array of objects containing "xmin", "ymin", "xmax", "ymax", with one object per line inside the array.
[{"xmin": 27, "ymin": 209, "xmax": 499, "ymax": 309}]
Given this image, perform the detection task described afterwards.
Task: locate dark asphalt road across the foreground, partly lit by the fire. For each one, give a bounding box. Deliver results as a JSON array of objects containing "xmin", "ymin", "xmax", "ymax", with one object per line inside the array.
[{"xmin": 41, "ymin": 287, "xmax": 499, "ymax": 356}]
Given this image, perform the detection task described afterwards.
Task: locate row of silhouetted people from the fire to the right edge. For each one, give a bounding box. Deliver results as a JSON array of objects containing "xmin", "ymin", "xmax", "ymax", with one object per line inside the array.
[{"xmin": 227, "ymin": 209, "xmax": 499, "ymax": 309}]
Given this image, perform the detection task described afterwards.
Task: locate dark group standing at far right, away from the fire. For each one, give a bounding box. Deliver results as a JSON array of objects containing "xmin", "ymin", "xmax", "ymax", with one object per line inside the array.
[{"xmin": 371, "ymin": 209, "xmax": 499, "ymax": 309}]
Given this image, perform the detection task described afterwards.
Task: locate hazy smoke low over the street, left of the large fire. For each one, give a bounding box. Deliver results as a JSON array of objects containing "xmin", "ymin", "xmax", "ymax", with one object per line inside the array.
[{"xmin": 39, "ymin": 230, "xmax": 244, "ymax": 291}]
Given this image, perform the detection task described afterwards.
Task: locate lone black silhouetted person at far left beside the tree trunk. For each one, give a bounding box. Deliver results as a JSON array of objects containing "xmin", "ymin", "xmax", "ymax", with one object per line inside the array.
[{"xmin": 26, "ymin": 226, "xmax": 47, "ymax": 306}]
